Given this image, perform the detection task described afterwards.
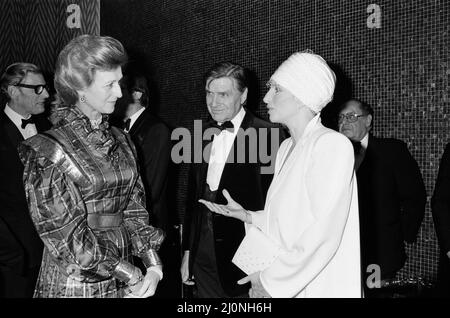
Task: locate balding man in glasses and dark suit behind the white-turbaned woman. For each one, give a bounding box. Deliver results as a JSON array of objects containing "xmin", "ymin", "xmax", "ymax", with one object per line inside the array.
[{"xmin": 339, "ymin": 100, "xmax": 426, "ymax": 297}]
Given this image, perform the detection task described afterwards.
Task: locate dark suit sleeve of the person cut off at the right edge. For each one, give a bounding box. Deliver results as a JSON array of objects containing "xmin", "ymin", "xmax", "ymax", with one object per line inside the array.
[{"xmin": 431, "ymin": 144, "xmax": 450, "ymax": 253}]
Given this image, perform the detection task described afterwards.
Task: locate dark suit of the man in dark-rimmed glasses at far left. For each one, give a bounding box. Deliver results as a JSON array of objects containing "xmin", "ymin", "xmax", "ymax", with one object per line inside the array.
[{"xmin": 0, "ymin": 110, "xmax": 50, "ymax": 297}]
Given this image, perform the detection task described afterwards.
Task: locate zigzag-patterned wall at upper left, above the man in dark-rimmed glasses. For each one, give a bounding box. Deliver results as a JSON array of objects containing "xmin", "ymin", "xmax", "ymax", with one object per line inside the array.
[{"xmin": 0, "ymin": 0, "xmax": 100, "ymax": 81}]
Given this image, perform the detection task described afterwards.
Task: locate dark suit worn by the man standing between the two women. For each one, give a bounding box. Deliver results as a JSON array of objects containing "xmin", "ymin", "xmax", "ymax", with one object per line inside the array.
[{"xmin": 183, "ymin": 111, "xmax": 281, "ymax": 297}]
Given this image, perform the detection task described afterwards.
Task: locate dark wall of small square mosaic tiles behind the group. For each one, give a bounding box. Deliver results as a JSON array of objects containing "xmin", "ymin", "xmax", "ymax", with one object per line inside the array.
[{"xmin": 101, "ymin": 0, "xmax": 450, "ymax": 281}]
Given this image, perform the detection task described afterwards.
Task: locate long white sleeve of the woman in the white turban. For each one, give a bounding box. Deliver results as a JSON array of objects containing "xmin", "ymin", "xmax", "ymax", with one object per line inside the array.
[{"xmin": 260, "ymin": 133, "xmax": 354, "ymax": 297}]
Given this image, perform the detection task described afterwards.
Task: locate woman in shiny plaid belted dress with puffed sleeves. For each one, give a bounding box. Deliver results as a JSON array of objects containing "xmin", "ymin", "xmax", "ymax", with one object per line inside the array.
[{"xmin": 19, "ymin": 35, "xmax": 164, "ymax": 298}]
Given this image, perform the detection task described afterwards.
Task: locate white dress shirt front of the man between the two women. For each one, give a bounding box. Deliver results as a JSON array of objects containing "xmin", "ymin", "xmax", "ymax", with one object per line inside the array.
[{"xmin": 206, "ymin": 108, "xmax": 245, "ymax": 191}]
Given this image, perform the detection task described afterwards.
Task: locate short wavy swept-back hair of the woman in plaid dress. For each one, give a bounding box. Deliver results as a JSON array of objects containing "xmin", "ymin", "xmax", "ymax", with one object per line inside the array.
[{"xmin": 55, "ymin": 34, "xmax": 128, "ymax": 105}]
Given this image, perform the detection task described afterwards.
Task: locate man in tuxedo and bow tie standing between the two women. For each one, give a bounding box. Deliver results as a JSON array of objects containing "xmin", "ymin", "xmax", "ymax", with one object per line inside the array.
[{"xmin": 181, "ymin": 62, "xmax": 281, "ymax": 298}]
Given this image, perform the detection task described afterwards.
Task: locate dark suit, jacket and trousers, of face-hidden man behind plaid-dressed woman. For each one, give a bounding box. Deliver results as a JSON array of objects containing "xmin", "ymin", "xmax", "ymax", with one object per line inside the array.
[{"xmin": 129, "ymin": 109, "xmax": 176, "ymax": 298}]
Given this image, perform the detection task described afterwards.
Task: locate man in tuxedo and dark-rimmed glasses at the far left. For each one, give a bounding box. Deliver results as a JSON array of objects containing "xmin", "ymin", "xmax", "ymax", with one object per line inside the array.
[{"xmin": 0, "ymin": 63, "xmax": 50, "ymax": 298}]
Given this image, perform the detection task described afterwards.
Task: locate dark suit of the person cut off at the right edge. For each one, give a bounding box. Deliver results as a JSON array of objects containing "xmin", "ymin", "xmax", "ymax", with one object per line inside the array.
[{"xmin": 431, "ymin": 143, "xmax": 450, "ymax": 297}]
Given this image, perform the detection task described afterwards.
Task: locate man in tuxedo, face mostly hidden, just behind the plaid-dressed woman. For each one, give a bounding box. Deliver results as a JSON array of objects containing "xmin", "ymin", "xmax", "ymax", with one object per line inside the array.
[{"xmin": 118, "ymin": 76, "xmax": 174, "ymax": 298}]
